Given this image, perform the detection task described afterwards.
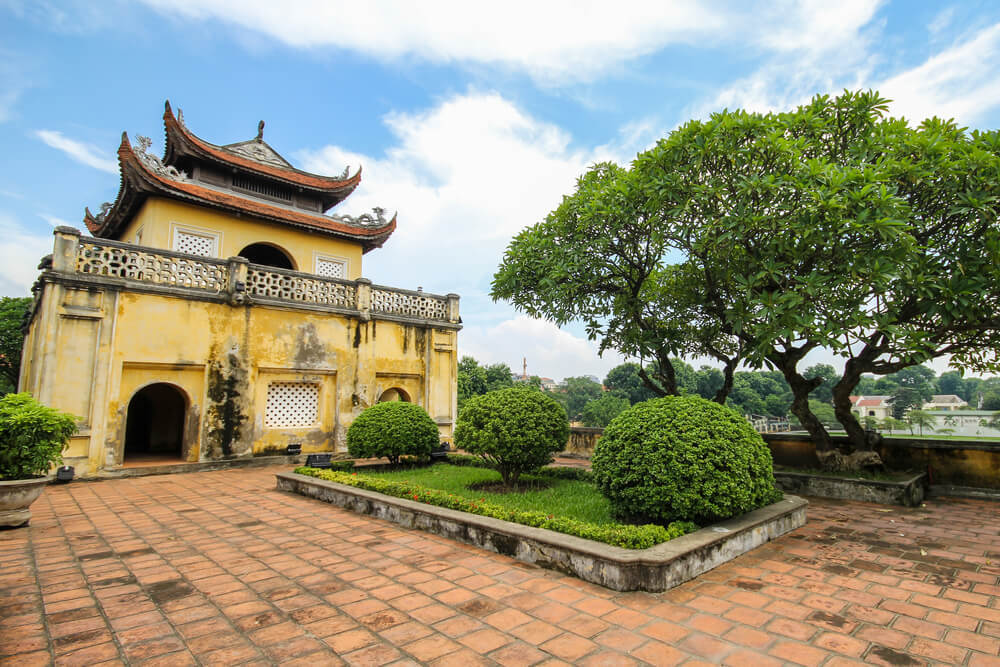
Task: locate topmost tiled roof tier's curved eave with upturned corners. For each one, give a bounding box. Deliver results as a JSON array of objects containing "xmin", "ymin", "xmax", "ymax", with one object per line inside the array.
[{"xmin": 163, "ymin": 101, "xmax": 361, "ymax": 208}]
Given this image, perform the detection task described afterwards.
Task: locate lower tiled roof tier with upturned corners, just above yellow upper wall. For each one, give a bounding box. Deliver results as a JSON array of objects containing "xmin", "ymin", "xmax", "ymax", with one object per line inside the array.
[{"xmin": 84, "ymin": 134, "xmax": 396, "ymax": 252}]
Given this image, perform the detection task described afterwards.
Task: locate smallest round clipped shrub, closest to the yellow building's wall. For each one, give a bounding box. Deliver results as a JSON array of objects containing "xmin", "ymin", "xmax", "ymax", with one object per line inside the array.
[{"xmin": 347, "ymin": 401, "xmax": 441, "ymax": 463}]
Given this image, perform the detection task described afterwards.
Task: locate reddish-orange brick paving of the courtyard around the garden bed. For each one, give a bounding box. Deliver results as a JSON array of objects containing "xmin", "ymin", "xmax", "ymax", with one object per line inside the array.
[{"xmin": 0, "ymin": 469, "xmax": 1000, "ymax": 667}]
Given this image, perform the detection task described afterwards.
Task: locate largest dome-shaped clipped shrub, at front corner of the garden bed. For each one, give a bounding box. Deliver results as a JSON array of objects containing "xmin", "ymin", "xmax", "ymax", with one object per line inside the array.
[{"xmin": 591, "ymin": 396, "xmax": 781, "ymax": 525}]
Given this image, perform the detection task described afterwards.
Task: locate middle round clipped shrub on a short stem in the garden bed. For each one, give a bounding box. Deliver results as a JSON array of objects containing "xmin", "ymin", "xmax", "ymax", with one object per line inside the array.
[{"xmin": 455, "ymin": 387, "xmax": 569, "ymax": 486}]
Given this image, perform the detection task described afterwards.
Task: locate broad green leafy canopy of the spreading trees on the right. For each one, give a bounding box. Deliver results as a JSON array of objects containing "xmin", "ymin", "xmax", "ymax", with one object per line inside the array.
[{"xmin": 492, "ymin": 91, "xmax": 1000, "ymax": 468}]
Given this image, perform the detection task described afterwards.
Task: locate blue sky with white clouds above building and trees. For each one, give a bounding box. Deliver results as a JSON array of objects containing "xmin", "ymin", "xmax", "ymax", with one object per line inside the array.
[{"xmin": 0, "ymin": 0, "xmax": 1000, "ymax": 378}]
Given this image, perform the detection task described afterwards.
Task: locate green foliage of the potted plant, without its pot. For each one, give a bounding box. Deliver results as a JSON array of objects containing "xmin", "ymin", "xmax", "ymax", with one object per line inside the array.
[{"xmin": 0, "ymin": 393, "xmax": 76, "ymax": 480}]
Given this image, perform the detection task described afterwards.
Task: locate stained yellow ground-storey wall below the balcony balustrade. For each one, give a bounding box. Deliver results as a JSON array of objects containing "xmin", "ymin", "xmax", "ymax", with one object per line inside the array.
[{"xmin": 20, "ymin": 231, "xmax": 457, "ymax": 476}]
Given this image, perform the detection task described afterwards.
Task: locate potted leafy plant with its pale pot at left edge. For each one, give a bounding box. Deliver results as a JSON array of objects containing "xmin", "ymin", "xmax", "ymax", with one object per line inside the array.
[{"xmin": 0, "ymin": 393, "xmax": 76, "ymax": 527}]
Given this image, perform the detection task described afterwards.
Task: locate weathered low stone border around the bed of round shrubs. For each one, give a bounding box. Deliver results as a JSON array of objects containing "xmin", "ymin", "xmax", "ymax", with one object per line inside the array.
[{"xmin": 276, "ymin": 472, "xmax": 808, "ymax": 592}]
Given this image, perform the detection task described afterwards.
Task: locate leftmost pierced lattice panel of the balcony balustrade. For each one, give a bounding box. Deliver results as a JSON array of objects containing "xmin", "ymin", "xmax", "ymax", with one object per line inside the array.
[{"xmin": 76, "ymin": 241, "xmax": 229, "ymax": 292}]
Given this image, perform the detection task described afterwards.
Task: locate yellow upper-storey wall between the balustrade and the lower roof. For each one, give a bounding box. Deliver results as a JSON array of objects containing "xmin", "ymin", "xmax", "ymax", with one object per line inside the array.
[{"xmin": 116, "ymin": 197, "xmax": 362, "ymax": 280}]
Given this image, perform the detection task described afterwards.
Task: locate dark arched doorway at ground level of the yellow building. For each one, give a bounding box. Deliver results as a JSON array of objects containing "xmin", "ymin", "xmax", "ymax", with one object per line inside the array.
[{"xmin": 122, "ymin": 382, "xmax": 187, "ymax": 464}]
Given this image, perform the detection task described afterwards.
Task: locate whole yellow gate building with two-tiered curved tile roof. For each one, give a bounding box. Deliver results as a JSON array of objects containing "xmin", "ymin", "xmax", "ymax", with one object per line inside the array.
[{"xmin": 20, "ymin": 103, "xmax": 461, "ymax": 475}]
